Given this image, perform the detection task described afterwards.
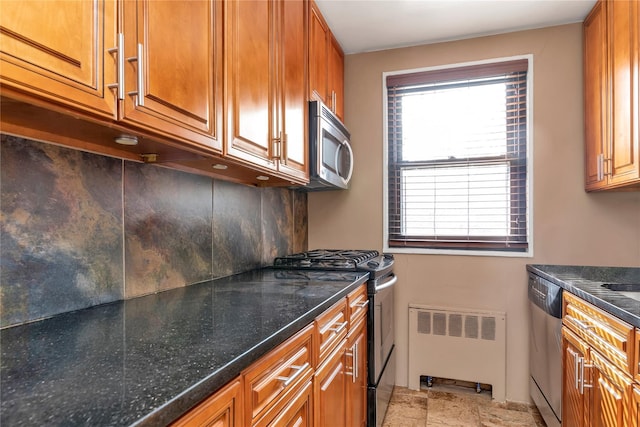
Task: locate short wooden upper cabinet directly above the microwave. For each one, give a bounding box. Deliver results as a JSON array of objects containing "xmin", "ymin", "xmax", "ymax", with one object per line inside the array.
[{"xmin": 309, "ymin": 1, "xmax": 344, "ymax": 121}]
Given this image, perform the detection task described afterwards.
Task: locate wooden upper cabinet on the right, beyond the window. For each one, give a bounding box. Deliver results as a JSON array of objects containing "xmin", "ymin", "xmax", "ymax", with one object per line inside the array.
[{"xmin": 584, "ymin": 0, "xmax": 640, "ymax": 191}]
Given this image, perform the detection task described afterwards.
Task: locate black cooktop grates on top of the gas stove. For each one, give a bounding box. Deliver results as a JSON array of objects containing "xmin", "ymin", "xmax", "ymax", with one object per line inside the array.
[{"xmin": 273, "ymin": 249, "xmax": 380, "ymax": 270}]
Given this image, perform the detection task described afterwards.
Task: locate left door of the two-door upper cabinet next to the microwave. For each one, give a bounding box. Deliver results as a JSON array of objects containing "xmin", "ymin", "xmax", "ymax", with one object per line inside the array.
[{"xmin": 225, "ymin": 0, "xmax": 277, "ymax": 169}]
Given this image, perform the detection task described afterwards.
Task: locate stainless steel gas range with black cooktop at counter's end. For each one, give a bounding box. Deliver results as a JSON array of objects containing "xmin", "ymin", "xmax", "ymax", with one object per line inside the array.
[{"xmin": 274, "ymin": 249, "xmax": 398, "ymax": 427}]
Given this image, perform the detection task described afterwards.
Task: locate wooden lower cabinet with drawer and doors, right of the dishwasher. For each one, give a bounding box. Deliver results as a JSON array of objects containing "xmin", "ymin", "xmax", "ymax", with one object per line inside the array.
[{"xmin": 562, "ymin": 292, "xmax": 640, "ymax": 427}]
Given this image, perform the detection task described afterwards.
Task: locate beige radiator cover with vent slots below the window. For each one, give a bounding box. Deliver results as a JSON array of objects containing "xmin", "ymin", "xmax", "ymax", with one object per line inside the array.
[{"xmin": 409, "ymin": 304, "xmax": 506, "ymax": 402}]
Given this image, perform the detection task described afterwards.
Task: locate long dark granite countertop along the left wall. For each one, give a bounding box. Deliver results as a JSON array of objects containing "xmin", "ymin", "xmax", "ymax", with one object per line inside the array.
[{"xmin": 0, "ymin": 269, "xmax": 367, "ymax": 426}]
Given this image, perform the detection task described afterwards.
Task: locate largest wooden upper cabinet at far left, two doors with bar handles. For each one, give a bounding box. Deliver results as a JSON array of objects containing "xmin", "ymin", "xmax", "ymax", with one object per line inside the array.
[{"xmin": 0, "ymin": 0, "xmax": 223, "ymax": 152}]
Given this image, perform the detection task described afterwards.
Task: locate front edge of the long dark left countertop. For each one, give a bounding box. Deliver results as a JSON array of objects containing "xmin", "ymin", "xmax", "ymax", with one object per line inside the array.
[{"xmin": 131, "ymin": 275, "xmax": 367, "ymax": 427}]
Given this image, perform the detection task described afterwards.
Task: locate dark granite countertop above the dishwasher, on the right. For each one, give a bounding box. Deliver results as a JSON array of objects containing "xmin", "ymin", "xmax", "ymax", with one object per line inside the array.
[{"xmin": 527, "ymin": 264, "xmax": 640, "ymax": 328}]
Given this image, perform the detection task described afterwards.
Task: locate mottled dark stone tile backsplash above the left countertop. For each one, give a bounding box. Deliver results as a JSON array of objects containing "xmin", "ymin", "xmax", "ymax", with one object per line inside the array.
[{"xmin": 0, "ymin": 134, "xmax": 307, "ymax": 327}]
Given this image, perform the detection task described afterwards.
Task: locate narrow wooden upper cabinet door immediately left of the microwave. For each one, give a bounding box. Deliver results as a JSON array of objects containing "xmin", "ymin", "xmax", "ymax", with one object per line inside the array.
[{"xmin": 278, "ymin": 0, "xmax": 309, "ymax": 180}]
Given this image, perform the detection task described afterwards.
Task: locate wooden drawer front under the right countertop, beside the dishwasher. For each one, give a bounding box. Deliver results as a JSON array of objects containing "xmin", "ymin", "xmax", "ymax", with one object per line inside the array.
[{"xmin": 562, "ymin": 292, "xmax": 635, "ymax": 375}]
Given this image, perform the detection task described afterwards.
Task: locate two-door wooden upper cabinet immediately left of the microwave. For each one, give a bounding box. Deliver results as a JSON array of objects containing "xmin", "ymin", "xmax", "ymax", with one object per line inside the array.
[{"xmin": 225, "ymin": 0, "xmax": 309, "ymax": 180}]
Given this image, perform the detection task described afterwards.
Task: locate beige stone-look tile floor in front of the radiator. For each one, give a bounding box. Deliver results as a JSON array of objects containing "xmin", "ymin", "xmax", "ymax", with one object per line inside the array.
[{"xmin": 383, "ymin": 385, "xmax": 545, "ymax": 427}]
